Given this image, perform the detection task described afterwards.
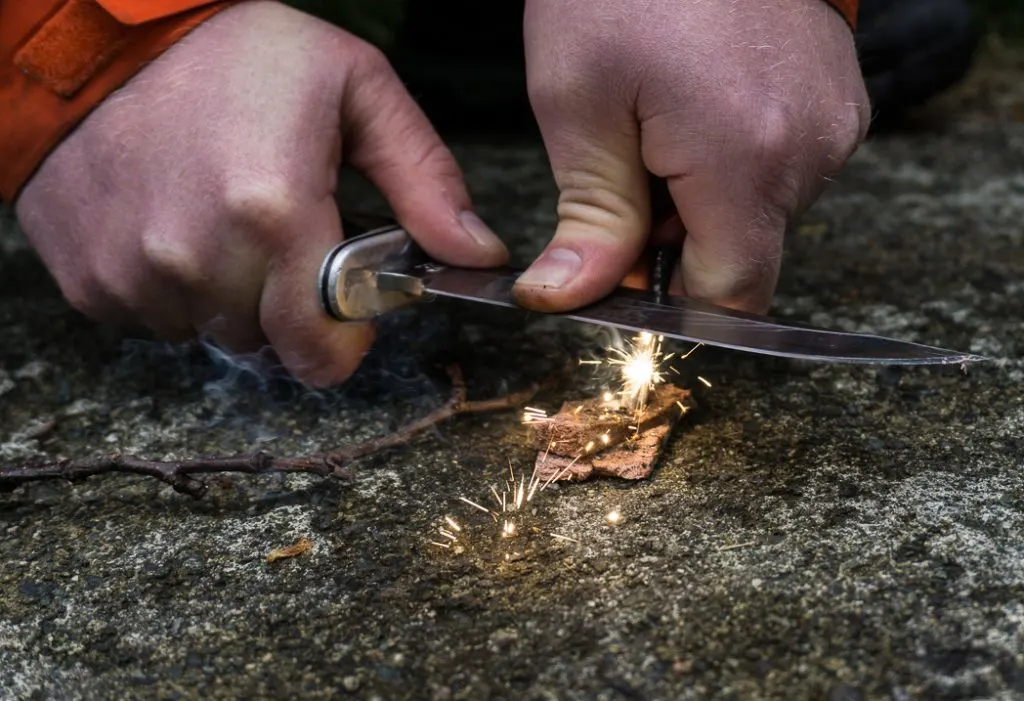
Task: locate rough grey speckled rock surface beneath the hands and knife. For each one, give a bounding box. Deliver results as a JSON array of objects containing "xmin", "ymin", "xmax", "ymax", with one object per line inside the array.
[{"xmin": 0, "ymin": 57, "xmax": 1024, "ymax": 701}]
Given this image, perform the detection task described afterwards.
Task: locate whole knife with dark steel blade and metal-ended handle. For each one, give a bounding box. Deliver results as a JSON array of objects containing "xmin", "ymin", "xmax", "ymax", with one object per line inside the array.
[{"xmin": 318, "ymin": 224, "xmax": 987, "ymax": 365}]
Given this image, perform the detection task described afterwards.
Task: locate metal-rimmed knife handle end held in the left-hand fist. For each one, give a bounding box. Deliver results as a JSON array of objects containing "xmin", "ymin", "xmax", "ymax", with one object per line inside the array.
[{"xmin": 318, "ymin": 223, "xmax": 426, "ymax": 321}]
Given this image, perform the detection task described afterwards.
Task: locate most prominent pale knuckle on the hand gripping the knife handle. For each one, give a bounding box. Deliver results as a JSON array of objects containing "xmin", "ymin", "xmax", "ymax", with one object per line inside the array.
[{"xmin": 221, "ymin": 173, "xmax": 299, "ymax": 234}]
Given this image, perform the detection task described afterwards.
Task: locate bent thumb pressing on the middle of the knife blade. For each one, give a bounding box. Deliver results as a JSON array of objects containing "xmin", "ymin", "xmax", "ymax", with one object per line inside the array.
[{"xmin": 513, "ymin": 91, "xmax": 650, "ymax": 312}]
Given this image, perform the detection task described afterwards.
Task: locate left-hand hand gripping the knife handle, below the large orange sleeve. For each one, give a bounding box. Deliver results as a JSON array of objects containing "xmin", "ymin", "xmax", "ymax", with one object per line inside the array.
[{"xmin": 16, "ymin": 1, "xmax": 507, "ymax": 386}]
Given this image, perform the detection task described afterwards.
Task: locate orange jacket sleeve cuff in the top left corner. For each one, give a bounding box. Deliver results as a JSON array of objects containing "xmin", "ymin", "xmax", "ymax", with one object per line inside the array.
[{"xmin": 0, "ymin": 0, "xmax": 238, "ymax": 203}]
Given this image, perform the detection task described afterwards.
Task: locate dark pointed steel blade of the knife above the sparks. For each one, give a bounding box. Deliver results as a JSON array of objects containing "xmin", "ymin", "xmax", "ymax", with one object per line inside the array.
[{"xmin": 379, "ymin": 264, "xmax": 986, "ymax": 365}]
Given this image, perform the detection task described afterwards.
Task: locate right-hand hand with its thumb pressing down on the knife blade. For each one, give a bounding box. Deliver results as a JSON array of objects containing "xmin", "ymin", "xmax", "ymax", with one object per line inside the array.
[{"xmin": 514, "ymin": 0, "xmax": 869, "ymax": 312}]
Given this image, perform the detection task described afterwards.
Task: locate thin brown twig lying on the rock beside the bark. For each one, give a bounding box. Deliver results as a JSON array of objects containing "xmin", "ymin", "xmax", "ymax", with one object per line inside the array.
[{"xmin": 0, "ymin": 365, "xmax": 551, "ymax": 498}]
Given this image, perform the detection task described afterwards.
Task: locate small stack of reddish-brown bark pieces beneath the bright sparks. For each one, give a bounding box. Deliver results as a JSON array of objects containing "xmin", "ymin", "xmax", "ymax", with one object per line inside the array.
[{"xmin": 531, "ymin": 385, "xmax": 694, "ymax": 481}]
